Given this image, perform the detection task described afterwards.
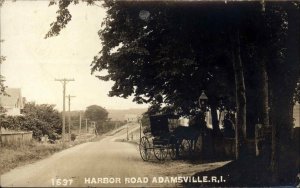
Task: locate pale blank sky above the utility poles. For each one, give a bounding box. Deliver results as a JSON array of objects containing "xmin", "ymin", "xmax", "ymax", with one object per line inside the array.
[{"xmin": 1, "ymin": 0, "xmax": 148, "ymax": 110}]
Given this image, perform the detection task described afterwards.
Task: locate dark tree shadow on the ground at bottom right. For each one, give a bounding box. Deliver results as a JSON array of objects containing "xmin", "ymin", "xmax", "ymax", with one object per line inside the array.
[{"xmin": 182, "ymin": 153, "xmax": 297, "ymax": 187}]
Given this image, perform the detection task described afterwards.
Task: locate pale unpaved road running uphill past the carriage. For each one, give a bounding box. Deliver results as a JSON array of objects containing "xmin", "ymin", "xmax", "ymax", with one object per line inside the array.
[{"xmin": 1, "ymin": 124, "xmax": 230, "ymax": 187}]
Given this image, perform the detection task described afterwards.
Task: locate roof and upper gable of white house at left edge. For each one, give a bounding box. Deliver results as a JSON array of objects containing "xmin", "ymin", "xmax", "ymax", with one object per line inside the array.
[{"xmin": 0, "ymin": 88, "xmax": 23, "ymax": 108}]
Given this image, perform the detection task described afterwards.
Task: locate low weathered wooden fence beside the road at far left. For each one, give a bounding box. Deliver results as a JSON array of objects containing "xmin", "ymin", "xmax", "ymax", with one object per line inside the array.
[{"xmin": 0, "ymin": 131, "xmax": 32, "ymax": 146}]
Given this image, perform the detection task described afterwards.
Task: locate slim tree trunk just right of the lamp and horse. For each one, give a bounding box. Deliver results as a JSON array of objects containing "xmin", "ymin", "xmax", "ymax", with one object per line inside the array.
[{"xmin": 232, "ymin": 31, "xmax": 246, "ymax": 159}]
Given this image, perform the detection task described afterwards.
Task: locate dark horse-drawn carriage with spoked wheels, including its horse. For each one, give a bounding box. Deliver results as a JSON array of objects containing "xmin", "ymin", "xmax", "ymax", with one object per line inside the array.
[{"xmin": 139, "ymin": 115, "xmax": 200, "ymax": 161}]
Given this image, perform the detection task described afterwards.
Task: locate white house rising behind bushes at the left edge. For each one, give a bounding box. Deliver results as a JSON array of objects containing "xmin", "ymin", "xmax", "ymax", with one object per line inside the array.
[{"xmin": 0, "ymin": 88, "xmax": 25, "ymax": 116}]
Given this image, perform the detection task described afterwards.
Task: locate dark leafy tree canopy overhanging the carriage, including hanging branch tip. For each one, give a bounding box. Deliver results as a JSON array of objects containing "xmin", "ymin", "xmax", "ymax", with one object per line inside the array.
[{"xmin": 47, "ymin": 0, "xmax": 298, "ymax": 114}]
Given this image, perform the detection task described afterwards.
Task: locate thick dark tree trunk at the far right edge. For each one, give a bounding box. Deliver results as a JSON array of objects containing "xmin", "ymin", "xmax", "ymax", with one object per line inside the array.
[{"xmin": 271, "ymin": 3, "xmax": 300, "ymax": 183}]
